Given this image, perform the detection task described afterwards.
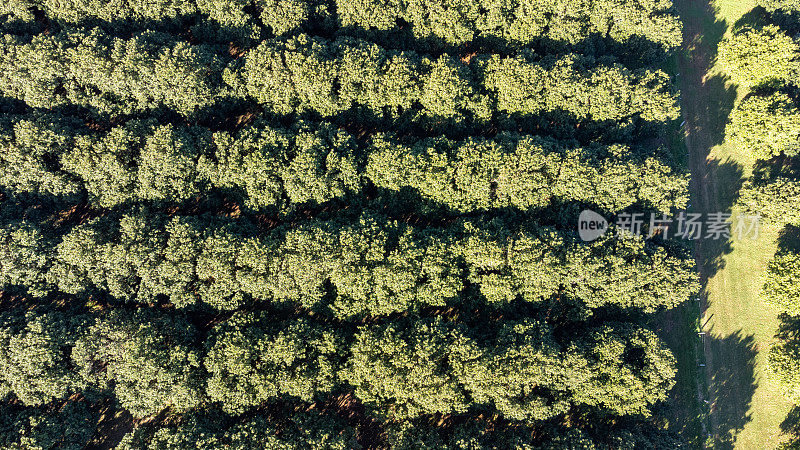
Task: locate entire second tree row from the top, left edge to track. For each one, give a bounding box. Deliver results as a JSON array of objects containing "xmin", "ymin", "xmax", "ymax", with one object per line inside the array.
[{"xmin": 0, "ymin": 28, "xmax": 678, "ymax": 128}]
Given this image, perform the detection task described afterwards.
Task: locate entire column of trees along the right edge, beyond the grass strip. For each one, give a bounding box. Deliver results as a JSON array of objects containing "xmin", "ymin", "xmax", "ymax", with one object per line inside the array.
[{"xmin": 719, "ymin": 0, "xmax": 800, "ymax": 450}]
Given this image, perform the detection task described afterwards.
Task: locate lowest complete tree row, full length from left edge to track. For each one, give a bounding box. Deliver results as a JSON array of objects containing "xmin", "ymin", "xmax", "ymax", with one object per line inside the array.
[{"xmin": 0, "ymin": 309, "xmax": 675, "ymax": 421}]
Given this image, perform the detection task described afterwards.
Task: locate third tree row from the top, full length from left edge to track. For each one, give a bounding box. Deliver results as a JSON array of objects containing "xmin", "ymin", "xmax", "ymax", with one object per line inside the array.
[{"xmin": 0, "ymin": 115, "xmax": 687, "ymax": 212}]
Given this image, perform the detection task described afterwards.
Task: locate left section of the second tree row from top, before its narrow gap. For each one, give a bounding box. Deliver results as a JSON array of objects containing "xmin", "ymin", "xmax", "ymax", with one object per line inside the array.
[{"xmin": 0, "ymin": 28, "xmax": 221, "ymax": 116}]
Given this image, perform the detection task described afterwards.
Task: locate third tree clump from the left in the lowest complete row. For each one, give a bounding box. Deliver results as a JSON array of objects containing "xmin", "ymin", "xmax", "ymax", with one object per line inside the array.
[{"xmin": 205, "ymin": 314, "xmax": 343, "ymax": 413}]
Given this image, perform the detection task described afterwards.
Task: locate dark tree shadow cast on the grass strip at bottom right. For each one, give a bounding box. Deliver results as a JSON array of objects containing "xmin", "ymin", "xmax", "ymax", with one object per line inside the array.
[{"xmin": 705, "ymin": 330, "xmax": 758, "ymax": 449}]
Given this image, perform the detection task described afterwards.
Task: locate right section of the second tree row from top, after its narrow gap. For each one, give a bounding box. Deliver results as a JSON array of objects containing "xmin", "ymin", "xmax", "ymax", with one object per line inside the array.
[{"xmin": 225, "ymin": 35, "xmax": 678, "ymax": 122}]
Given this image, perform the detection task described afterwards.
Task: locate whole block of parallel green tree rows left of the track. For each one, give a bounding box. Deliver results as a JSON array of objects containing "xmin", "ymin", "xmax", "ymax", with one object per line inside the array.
[{"xmin": 0, "ymin": 0, "xmax": 698, "ymax": 442}]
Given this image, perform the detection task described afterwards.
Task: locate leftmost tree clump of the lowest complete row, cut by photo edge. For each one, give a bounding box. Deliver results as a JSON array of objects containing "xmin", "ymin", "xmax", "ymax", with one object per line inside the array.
[{"xmin": 0, "ymin": 311, "xmax": 85, "ymax": 406}]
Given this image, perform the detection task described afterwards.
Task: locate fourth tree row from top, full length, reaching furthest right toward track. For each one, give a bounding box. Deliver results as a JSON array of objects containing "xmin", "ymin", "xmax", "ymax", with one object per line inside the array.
[{"xmin": 0, "ymin": 210, "xmax": 697, "ymax": 318}]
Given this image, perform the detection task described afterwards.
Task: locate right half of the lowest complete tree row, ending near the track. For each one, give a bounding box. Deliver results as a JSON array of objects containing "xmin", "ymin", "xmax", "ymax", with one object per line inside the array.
[{"xmin": 343, "ymin": 319, "xmax": 675, "ymax": 421}]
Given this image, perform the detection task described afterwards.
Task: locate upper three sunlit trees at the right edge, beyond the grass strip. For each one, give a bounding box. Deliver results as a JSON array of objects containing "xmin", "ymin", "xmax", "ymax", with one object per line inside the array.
[{"xmin": 718, "ymin": 7, "xmax": 800, "ymax": 224}]
